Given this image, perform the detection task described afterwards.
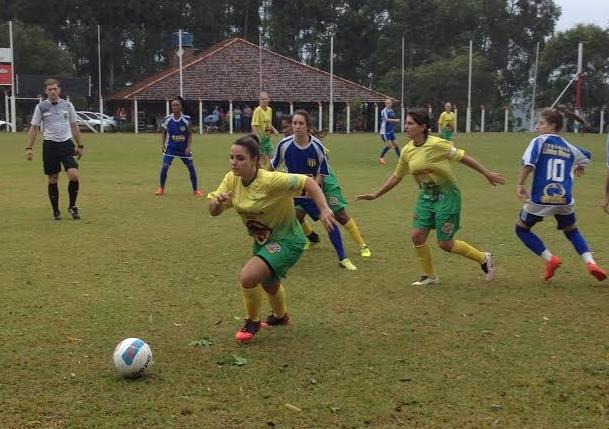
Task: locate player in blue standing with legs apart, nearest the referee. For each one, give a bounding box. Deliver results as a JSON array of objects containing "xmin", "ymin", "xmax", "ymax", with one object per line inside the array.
[{"xmin": 154, "ymin": 98, "xmax": 203, "ymax": 197}]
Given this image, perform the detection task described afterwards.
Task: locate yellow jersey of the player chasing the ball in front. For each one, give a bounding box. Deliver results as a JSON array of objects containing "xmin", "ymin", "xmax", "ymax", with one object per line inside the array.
[{"xmin": 207, "ymin": 169, "xmax": 307, "ymax": 245}]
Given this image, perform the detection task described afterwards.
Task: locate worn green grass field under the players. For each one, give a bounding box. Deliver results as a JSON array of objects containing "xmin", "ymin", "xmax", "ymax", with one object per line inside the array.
[{"xmin": 0, "ymin": 134, "xmax": 609, "ymax": 428}]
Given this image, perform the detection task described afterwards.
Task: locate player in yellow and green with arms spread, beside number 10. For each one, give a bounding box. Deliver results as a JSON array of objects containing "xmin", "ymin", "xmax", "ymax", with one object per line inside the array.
[{"xmin": 356, "ymin": 108, "xmax": 505, "ymax": 286}]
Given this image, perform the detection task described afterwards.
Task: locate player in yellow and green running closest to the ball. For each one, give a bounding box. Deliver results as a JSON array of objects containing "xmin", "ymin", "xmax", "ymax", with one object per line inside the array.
[{"xmin": 207, "ymin": 135, "xmax": 336, "ymax": 342}]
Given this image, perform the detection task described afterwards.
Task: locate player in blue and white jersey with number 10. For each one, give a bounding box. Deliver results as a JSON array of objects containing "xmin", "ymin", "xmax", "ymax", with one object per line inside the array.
[{"xmin": 516, "ymin": 109, "xmax": 607, "ymax": 281}]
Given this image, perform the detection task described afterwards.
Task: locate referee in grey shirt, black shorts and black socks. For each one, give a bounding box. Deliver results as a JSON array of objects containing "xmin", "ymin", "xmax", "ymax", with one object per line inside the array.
[{"xmin": 25, "ymin": 79, "xmax": 85, "ymax": 220}]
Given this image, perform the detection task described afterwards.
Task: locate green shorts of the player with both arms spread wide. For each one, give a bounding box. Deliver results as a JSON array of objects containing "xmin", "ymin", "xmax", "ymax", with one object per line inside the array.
[{"xmin": 412, "ymin": 191, "xmax": 461, "ymax": 241}]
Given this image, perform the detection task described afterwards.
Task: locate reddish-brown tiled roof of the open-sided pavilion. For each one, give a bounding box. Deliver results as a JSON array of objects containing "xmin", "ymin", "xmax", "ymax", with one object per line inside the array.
[{"xmin": 106, "ymin": 38, "xmax": 388, "ymax": 103}]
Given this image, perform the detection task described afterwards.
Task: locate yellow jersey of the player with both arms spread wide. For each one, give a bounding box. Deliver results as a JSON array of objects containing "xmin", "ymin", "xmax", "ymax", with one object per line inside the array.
[{"xmin": 393, "ymin": 136, "xmax": 465, "ymax": 200}]
